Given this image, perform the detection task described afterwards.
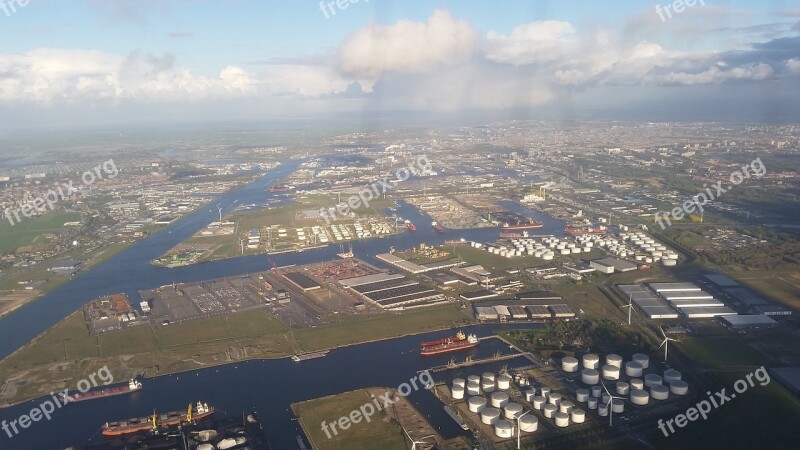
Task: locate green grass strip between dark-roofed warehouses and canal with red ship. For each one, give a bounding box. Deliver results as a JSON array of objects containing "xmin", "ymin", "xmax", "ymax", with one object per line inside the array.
[{"xmin": 294, "ymin": 305, "xmax": 467, "ymax": 351}]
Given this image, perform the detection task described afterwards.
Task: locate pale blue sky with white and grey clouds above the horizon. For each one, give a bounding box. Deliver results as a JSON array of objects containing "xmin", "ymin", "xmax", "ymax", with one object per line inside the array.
[{"xmin": 0, "ymin": 0, "xmax": 800, "ymax": 131}]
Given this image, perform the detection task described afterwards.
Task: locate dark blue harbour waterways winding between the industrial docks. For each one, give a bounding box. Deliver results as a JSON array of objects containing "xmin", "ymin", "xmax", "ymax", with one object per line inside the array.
[{"xmin": 0, "ymin": 161, "xmax": 563, "ymax": 450}]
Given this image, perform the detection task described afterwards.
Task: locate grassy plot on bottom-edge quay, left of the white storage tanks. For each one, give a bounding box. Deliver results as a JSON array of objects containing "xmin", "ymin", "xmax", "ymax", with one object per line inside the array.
[{"xmin": 292, "ymin": 390, "xmax": 408, "ymax": 450}]
